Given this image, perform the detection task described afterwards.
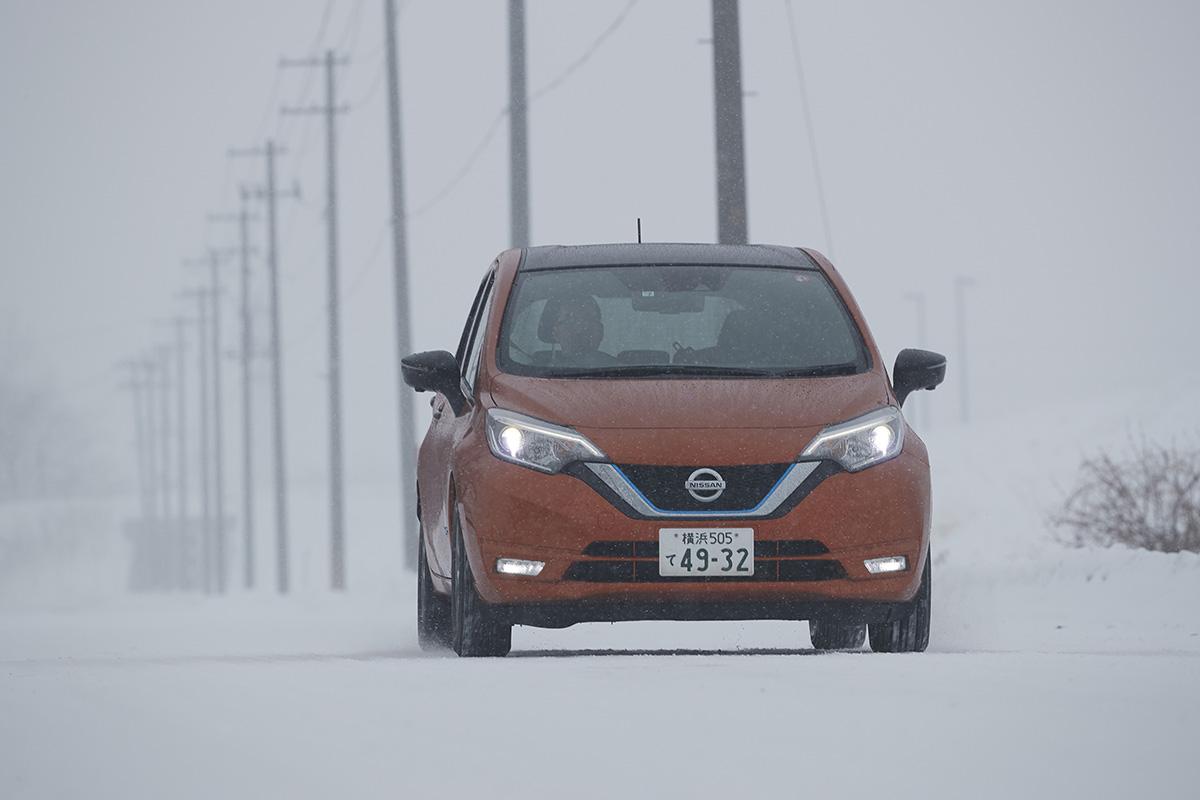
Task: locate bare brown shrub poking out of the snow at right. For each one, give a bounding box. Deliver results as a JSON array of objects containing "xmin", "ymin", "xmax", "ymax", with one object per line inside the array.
[{"xmin": 1051, "ymin": 441, "xmax": 1200, "ymax": 553}]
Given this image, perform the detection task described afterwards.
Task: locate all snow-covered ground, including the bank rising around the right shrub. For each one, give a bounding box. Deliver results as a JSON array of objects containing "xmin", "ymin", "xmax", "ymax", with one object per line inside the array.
[{"xmin": 7, "ymin": 383, "xmax": 1200, "ymax": 798}]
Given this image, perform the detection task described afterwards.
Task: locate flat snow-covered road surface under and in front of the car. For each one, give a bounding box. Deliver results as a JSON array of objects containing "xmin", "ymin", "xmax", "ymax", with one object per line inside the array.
[{"xmin": 0, "ymin": 599, "xmax": 1200, "ymax": 798}]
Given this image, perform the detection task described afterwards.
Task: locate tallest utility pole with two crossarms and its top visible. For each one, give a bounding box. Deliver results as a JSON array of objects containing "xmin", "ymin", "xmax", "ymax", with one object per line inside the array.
[{"xmin": 280, "ymin": 50, "xmax": 349, "ymax": 591}]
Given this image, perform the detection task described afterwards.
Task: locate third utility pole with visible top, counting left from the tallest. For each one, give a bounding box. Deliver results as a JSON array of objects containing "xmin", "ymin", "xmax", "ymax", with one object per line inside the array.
[{"xmin": 209, "ymin": 186, "xmax": 256, "ymax": 589}]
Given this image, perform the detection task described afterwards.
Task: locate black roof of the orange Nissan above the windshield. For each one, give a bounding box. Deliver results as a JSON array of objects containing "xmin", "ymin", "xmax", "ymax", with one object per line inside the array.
[{"xmin": 518, "ymin": 242, "xmax": 820, "ymax": 272}]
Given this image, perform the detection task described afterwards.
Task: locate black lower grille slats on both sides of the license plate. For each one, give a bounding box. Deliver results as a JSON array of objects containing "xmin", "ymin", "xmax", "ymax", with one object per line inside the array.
[{"xmin": 563, "ymin": 539, "xmax": 846, "ymax": 583}]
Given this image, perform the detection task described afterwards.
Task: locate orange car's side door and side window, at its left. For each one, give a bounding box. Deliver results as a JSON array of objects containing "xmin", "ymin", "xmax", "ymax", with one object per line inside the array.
[{"xmin": 416, "ymin": 269, "xmax": 496, "ymax": 577}]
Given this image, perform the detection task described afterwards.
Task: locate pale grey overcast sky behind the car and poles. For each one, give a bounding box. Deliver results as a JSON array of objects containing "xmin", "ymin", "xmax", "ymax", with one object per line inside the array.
[{"xmin": 0, "ymin": 0, "xmax": 1200, "ymax": 491}]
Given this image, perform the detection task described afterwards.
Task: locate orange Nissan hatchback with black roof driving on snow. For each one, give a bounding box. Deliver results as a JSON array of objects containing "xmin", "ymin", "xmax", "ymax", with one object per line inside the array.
[{"xmin": 403, "ymin": 245, "xmax": 946, "ymax": 656}]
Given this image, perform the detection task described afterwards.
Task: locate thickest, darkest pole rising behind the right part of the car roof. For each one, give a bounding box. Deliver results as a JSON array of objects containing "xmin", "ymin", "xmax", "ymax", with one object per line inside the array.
[{"xmin": 713, "ymin": 0, "xmax": 749, "ymax": 245}]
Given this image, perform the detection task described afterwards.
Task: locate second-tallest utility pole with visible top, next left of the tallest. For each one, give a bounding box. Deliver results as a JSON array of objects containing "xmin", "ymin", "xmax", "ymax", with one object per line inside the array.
[{"xmin": 229, "ymin": 139, "xmax": 300, "ymax": 595}]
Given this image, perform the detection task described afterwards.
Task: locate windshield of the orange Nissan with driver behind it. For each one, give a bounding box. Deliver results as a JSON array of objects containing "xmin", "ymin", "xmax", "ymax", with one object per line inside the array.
[{"xmin": 497, "ymin": 265, "xmax": 868, "ymax": 378}]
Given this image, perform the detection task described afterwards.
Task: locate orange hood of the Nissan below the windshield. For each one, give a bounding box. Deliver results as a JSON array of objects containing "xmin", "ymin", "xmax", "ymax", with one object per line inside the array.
[{"xmin": 490, "ymin": 371, "xmax": 888, "ymax": 429}]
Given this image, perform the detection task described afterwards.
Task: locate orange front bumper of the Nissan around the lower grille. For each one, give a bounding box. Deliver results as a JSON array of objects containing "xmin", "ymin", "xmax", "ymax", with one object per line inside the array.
[{"xmin": 456, "ymin": 443, "xmax": 930, "ymax": 626}]
